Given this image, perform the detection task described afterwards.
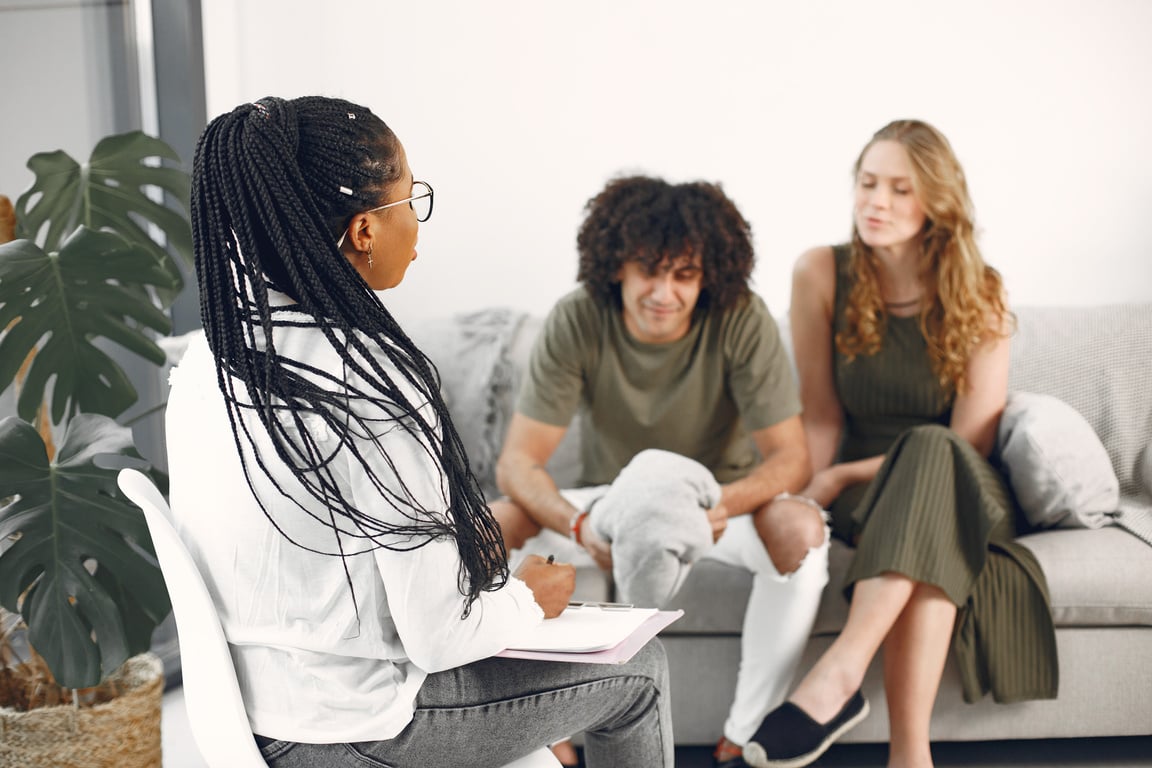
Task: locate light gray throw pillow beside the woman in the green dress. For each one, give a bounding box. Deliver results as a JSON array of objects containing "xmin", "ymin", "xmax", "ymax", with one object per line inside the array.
[{"xmin": 999, "ymin": 391, "xmax": 1120, "ymax": 529}]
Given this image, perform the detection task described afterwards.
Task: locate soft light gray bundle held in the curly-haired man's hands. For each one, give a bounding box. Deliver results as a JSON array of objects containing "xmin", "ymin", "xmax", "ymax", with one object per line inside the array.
[{"xmin": 588, "ymin": 449, "xmax": 720, "ymax": 608}]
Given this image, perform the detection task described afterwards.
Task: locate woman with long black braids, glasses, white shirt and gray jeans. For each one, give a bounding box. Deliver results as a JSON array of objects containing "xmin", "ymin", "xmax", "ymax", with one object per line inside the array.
[{"xmin": 167, "ymin": 97, "xmax": 673, "ymax": 768}]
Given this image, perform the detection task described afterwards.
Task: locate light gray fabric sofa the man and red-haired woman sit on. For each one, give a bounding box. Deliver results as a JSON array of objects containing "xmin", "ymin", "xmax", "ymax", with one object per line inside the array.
[{"xmin": 409, "ymin": 304, "xmax": 1152, "ymax": 745}]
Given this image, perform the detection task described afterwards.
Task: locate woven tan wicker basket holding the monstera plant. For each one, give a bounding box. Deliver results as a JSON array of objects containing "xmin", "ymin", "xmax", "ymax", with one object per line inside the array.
[{"xmin": 0, "ymin": 653, "xmax": 164, "ymax": 768}]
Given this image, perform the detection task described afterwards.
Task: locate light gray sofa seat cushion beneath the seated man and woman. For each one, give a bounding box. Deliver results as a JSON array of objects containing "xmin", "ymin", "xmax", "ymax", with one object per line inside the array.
[{"xmin": 666, "ymin": 526, "xmax": 1152, "ymax": 634}]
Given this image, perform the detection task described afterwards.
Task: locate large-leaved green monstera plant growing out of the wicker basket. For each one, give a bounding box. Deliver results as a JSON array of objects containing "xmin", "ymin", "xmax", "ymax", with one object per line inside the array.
[{"xmin": 0, "ymin": 131, "xmax": 191, "ymax": 689}]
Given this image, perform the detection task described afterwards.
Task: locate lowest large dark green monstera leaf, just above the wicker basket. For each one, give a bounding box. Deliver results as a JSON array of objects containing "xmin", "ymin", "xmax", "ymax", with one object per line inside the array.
[{"xmin": 0, "ymin": 415, "xmax": 172, "ymax": 687}]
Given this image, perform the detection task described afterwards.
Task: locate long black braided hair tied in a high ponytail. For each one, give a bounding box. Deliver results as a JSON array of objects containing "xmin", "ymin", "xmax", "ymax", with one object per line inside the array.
[{"xmin": 191, "ymin": 97, "xmax": 508, "ymax": 616}]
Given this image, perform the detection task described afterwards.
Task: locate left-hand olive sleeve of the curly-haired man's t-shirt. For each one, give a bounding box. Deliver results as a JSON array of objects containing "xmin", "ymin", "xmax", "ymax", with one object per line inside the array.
[{"xmin": 516, "ymin": 294, "xmax": 600, "ymax": 427}]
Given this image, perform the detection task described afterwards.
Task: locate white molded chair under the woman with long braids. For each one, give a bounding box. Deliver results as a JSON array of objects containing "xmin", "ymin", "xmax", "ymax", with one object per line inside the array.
[{"xmin": 116, "ymin": 470, "xmax": 560, "ymax": 768}]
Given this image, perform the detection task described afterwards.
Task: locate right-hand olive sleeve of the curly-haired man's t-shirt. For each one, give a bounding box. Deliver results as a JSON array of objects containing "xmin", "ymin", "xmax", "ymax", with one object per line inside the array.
[{"xmin": 725, "ymin": 296, "xmax": 801, "ymax": 432}]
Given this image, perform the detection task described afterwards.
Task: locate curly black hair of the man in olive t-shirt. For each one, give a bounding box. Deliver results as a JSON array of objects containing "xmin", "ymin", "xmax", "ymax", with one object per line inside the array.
[{"xmin": 576, "ymin": 176, "xmax": 756, "ymax": 311}]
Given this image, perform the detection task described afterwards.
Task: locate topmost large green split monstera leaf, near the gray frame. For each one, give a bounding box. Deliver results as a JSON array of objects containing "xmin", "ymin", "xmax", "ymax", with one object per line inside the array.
[{"xmin": 16, "ymin": 131, "xmax": 192, "ymax": 306}]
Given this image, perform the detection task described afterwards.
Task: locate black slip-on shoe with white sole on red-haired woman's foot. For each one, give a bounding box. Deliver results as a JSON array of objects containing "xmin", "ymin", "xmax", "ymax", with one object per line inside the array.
[{"xmin": 744, "ymin": 691, "xmax": 869, "ymax": 768}]
